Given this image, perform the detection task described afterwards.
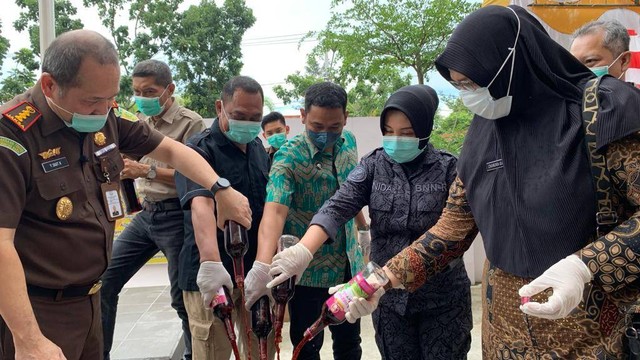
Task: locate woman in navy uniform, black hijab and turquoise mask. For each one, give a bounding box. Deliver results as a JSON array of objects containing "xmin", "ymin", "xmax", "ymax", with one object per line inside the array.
[{"xmin": 272, "ymin": 85, "xmax": 473, "ymax": 360}]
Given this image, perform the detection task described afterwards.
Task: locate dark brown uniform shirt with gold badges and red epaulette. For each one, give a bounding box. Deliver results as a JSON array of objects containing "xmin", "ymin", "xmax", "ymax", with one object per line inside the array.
[{"xmin": 0, "ymin": 82, "xmax": 163, "ymax": 289}]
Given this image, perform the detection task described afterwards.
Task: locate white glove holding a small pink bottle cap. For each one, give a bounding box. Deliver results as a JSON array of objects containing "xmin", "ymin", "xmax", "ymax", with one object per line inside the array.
[{"xmin": 518, "ymin": 255, "xmax": 593, "ymax": 320}]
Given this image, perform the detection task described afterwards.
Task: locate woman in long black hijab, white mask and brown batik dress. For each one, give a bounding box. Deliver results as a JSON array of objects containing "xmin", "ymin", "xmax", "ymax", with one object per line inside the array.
[{"xmin": 338, "ymin": 6, "xmax": 640, "ymax": 359}]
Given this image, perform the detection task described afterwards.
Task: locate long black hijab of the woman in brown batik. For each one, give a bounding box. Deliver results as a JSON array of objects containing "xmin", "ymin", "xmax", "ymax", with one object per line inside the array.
[{"xmin": 436, "ymin": 6, "xmax": 640, "ymax": 277}]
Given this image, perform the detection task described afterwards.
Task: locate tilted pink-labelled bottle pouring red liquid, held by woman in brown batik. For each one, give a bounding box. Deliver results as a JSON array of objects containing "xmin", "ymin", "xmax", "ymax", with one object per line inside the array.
[{"xmin": 292, "ymin": 261, "xmax": 389, "ymax": 360}]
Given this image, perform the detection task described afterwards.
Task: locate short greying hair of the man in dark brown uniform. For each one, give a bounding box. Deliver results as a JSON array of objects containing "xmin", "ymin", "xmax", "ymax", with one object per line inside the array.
[{"xmin": 42, "ymin": 30, "xmax": 120, "ymax": 89}]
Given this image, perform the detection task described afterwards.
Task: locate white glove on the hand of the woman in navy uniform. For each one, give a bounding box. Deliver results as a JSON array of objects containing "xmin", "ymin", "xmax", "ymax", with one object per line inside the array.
[{"xmin": 267, "ymin": 243, "xmax": 313, "ymax": 289}]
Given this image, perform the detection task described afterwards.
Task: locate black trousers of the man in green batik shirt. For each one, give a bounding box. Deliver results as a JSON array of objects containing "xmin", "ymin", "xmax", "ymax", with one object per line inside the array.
[{"xmin": 289, "ymin": 286, "xmax": 362, "ymax": 360}]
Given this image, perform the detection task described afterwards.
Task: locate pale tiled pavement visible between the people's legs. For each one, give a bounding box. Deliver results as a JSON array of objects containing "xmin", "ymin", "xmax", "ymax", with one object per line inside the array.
[{"xmin": 111, "ymin": 265, "xmax": 482, "ymax": 360}]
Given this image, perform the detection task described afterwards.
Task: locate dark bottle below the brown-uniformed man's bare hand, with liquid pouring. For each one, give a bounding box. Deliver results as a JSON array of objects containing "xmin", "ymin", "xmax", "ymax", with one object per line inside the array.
[{"xmin": 224, "ymin": 220, "xmax": 251, "ymax": 360}]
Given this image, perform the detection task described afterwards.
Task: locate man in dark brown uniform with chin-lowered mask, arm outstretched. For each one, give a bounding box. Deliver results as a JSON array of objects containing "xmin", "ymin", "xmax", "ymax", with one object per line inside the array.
[{"xmin": 0, "ymin": 30, "xmax": 251, "ymax": 360}]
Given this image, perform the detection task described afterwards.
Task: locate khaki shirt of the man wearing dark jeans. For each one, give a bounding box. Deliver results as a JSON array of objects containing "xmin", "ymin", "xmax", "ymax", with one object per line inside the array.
[{"xmin": 136, "ymin": 99, "xmax": 207, "ymax": 202}]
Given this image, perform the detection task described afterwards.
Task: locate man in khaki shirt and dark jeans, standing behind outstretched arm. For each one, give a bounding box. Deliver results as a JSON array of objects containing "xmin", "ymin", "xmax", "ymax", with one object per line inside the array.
[{"xmin": 101, "ymin": 60, "xmax": 206, "ymax": 360}]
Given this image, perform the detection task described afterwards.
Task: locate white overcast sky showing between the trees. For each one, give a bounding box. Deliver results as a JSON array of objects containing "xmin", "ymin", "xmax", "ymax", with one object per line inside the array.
[{"xmin": 0, "ymin": 0, "xmax": 455, "ymax": 105}]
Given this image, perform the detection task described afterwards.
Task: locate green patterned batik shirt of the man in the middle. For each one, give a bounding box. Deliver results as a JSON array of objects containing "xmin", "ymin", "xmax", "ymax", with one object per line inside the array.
[{"xmin": 266, "ymin": 130, "xmax": 364, "ymax": 288}]
